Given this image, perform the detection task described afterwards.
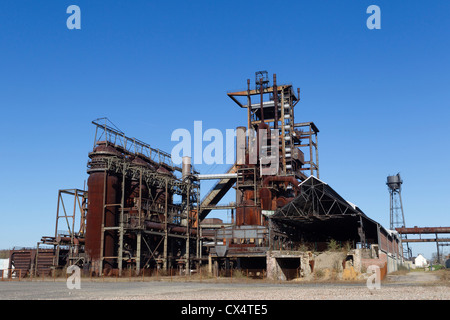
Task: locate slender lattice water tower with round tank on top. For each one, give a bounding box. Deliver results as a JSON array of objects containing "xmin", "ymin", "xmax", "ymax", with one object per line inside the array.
[{"xmin": 386, "ymin": 173, "xmax": 412, "ymax": 258}]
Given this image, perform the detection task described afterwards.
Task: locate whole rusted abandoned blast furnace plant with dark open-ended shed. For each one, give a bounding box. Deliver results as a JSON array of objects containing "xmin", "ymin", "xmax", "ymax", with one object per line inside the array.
[{"xmin": 7, "ymin": 71, "xmax": 403, "ymax": 279}]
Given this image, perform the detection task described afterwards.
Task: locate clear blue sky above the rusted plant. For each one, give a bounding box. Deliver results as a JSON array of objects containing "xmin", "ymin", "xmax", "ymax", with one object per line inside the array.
[{"xmin": 0, "ymin": 0, "xmax": 450, "ymax": 257}]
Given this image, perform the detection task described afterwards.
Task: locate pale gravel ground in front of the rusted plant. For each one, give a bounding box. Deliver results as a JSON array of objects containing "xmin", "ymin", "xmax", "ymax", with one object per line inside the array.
[{"xmin": 0, "ymin": 273, "xmax": 450, "ymax": 301}]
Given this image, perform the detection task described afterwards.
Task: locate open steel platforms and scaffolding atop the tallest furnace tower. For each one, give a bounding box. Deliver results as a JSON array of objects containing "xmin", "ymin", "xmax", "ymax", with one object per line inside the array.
[{"xmin": 227, "ymin": 71, "xmax": 319, "ymax": 181}]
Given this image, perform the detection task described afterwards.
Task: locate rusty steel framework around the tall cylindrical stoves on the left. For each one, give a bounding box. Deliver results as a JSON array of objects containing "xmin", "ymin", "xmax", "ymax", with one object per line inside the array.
[{"xmin": 88, "ymin": 119, "xmax": 201, "ymax": 275}]
